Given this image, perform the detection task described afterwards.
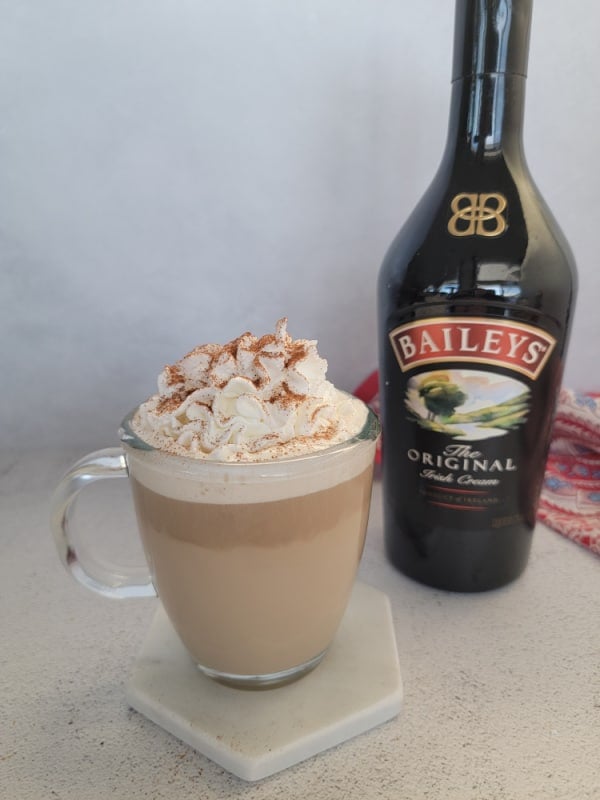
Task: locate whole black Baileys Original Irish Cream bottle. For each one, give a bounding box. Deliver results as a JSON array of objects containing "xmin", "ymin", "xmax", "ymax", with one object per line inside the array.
[{"xmin": 378, "ymin": 0, "xmax": 576, "ymax": 591}]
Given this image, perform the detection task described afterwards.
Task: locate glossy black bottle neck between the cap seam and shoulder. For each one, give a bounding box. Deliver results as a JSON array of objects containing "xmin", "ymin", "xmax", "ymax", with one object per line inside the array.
[{"xmin": 446, "ymin": 72, "xmax": 525, "ymax": 161}]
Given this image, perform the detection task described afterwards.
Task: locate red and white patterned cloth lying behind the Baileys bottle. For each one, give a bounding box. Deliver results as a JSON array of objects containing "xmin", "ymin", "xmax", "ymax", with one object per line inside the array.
[{"xmin": 355, "ymin": 371, "xmax": 600, "ymax": 555}]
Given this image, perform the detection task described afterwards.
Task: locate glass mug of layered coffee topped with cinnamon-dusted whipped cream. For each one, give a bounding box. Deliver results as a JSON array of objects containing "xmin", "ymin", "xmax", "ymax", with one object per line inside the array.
[{"xmin": 52, "ymin": 320, "xmax": 379, "ymax": 687}]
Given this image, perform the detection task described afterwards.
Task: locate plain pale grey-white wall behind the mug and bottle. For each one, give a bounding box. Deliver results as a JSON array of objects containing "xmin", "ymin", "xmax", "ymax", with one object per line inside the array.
[{"xmin": 0, "ymin": 0, "xmax": 600, "ymax": 448}]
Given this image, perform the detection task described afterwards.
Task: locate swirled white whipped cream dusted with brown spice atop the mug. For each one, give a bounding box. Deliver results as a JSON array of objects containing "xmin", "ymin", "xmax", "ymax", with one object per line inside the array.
[{"xmin": 132, "ymin": 318, "xmax": 367, "ymax": 461}]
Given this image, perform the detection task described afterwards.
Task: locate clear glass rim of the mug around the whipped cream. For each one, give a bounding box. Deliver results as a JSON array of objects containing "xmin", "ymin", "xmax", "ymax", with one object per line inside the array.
[{"xmin": 119, "ymin": 392, "xmax": 381, "ymax": 469}]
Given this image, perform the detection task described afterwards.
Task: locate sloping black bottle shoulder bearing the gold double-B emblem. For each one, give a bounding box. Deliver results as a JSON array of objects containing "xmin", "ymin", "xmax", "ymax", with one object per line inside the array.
[{"xmin": 379, "ymin": 153, "xmax": 577, "ymax": 316}]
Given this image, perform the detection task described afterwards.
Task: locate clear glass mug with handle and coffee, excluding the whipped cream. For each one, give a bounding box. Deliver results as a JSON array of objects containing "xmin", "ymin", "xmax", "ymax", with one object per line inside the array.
[{"xmin": 52, "ymin": 410, "xmax": 379, "ymax": 687}]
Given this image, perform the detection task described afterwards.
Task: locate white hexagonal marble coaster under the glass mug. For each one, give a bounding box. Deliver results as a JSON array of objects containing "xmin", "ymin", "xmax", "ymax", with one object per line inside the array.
[{"xmin": 126, "ymin": 582, "xmax": 403, "ymax": 781}]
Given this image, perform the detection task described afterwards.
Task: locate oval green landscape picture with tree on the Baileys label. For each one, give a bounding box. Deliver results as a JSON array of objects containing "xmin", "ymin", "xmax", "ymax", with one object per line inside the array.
[{"xmin": 405, "ymin": 369, "xmax": 531, "ymax": 441}]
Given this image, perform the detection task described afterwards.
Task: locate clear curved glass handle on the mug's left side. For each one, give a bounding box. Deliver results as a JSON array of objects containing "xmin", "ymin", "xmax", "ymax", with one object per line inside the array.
[{"xmin": 50, "ymin": 447, "xmax": 156, "ymax": 598}]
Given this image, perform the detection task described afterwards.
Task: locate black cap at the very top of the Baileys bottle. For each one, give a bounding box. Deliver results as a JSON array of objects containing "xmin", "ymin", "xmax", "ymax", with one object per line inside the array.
[{"xmin": 452, "ymin": 0, "xmax": 532, "ymax": 81}]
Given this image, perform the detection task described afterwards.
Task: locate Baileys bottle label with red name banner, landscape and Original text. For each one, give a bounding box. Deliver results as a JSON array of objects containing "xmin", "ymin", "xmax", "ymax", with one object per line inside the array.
[{"xmin": 384, "ymin": 316, "xmax": 557, "ymax": 528}]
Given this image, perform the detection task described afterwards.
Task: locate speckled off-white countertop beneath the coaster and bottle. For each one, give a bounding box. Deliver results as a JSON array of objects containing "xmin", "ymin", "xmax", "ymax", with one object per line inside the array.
[{"xmin": 0, "ymin": 451, "xmax": 600, "ymax": 800}]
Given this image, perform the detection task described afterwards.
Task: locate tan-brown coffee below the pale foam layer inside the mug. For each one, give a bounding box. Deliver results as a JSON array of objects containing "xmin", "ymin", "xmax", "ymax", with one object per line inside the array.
[{"xmin": 132, "ymin": 468, "xmax": 372, "ymax": 675}]
